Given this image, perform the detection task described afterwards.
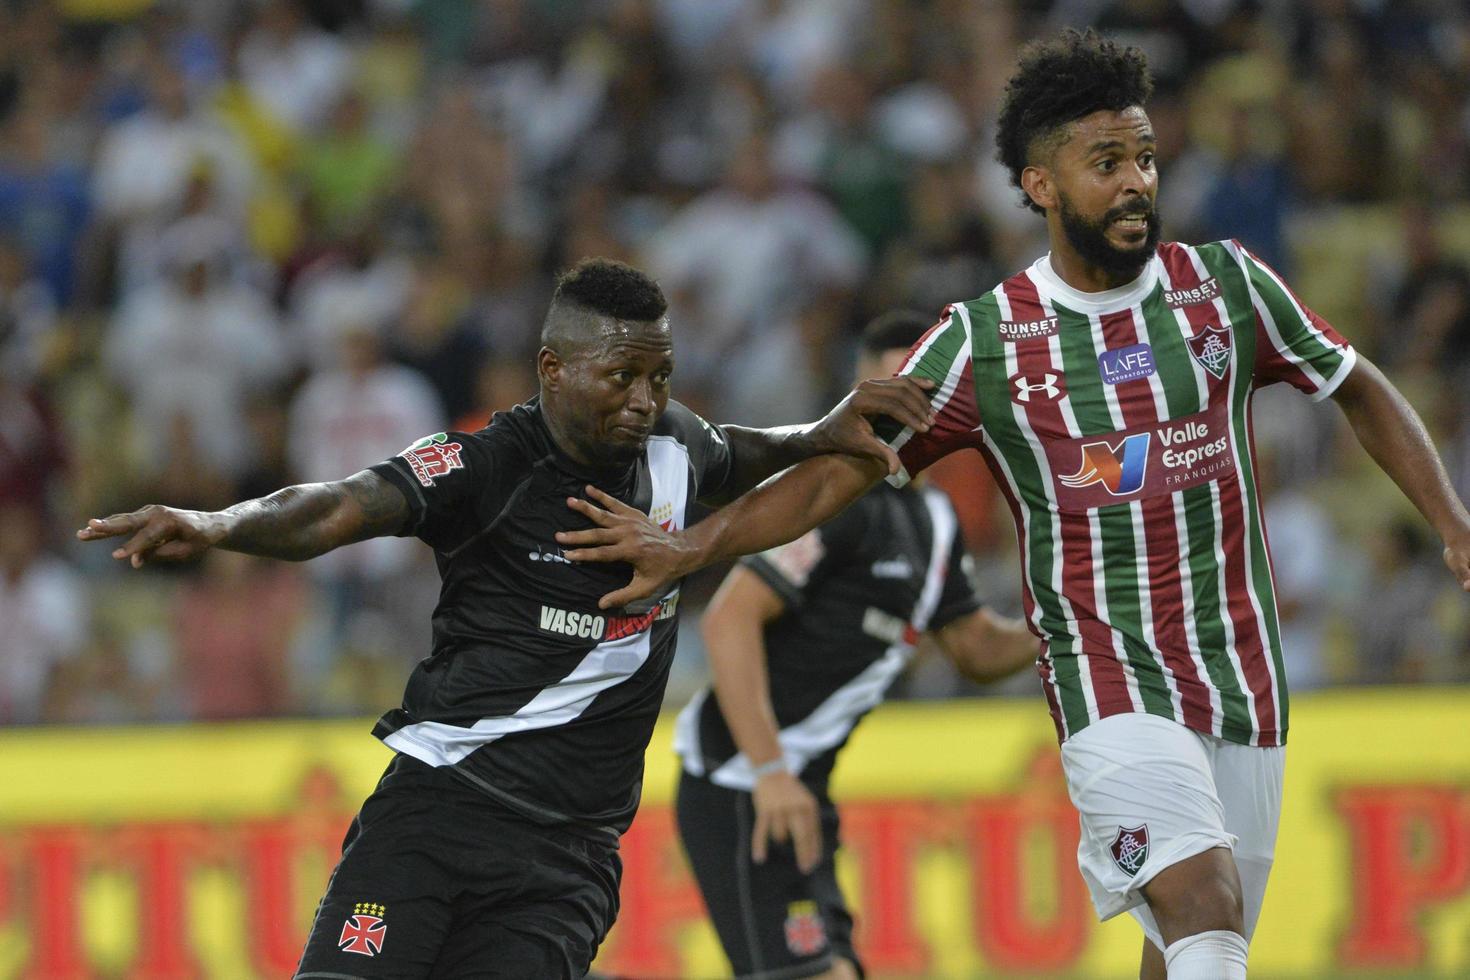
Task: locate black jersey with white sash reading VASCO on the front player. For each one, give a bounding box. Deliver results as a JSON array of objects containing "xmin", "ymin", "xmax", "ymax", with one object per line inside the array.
[{"xmin": 373, "ymin": 400, "xmax": 732, "ymax": 833}]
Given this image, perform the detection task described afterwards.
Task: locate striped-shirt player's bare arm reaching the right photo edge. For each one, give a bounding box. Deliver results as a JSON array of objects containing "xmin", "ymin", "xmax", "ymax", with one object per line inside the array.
[{"xmin": 1332, "ymin": 354, "xmax": 1470, "ymax": 592}]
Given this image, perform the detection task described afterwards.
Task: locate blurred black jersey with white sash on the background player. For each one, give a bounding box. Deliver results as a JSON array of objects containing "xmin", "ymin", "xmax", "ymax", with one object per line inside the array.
[{"xmin": 675, "ymin": 483, "xmax": 980, "ymax": 790}]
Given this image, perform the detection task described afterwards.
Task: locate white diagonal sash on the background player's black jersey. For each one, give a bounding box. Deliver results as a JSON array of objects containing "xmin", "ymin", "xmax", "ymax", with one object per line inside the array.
[{"xmin": 679, "ymin": 488, "xmax": 958, "ymax": 792}]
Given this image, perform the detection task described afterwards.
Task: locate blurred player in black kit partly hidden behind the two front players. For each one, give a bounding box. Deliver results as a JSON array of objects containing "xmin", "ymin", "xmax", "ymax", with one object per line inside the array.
[{"xmin": 675, "ymin": 311, "xmax": 1038, "ymax": 980}]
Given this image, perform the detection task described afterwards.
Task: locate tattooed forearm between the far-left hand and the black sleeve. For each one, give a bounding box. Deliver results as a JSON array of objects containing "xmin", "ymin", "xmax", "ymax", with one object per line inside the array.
[{"xmin": 219, "ymin": 472, "xmax": 409, "ymax": 561}]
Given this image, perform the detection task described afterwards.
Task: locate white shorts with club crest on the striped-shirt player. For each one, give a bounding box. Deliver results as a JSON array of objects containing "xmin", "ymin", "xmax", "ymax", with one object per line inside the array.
[{"xmin": 1061, "ymin": 713, "xmax": 1286, "ymax": 949}]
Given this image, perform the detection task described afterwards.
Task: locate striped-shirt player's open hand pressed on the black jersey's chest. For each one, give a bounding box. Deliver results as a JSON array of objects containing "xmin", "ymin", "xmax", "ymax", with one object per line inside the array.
[{"xmin": 556, "ymin": 486, "xmax": 685, "ymax": 610}]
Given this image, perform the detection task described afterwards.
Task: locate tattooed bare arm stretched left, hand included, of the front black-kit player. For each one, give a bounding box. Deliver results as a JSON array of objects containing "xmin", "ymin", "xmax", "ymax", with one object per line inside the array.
[{"xmin": 76, "ymin": 470, "xmax": 409, "ymax": 569}]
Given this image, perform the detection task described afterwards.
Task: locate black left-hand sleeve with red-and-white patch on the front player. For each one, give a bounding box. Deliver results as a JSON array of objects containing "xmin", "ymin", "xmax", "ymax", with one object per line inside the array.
[{"xmin": 370, "ymin": 430, "xmax": 523, "ymax": 551}]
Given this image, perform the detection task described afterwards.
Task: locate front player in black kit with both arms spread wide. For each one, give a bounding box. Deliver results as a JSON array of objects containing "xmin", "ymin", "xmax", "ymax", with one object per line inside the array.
[{"xmin": 78, "ymin": 260, "xmax": 929, "ymax": 980}]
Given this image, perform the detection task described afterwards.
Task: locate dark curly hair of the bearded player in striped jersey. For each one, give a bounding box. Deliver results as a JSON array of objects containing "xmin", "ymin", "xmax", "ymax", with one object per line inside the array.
[{"xmin": 995, "ymin": 28, "xmax": 1154, "ymax": 215}]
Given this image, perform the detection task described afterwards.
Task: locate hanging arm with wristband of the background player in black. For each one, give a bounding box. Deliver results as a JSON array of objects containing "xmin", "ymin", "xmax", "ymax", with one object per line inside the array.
[{"xmin": 700, "ymin": 566, "xmax": 822, "ymax": 871}]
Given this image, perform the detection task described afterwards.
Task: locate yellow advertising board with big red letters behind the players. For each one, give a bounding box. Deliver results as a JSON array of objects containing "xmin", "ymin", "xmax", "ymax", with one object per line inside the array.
[{"xmin": 0, "ymin": 689, "xmax": 1470, "ymax": 980}]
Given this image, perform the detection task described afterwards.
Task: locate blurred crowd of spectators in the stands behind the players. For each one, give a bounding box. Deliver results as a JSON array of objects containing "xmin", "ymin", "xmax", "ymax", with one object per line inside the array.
[{"xmin": 0, "ymin": 0, "xmax": 1470, "ymax": 724}]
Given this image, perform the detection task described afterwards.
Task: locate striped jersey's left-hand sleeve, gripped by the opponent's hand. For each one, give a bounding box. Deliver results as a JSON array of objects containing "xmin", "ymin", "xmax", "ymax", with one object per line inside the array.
[{"xmin": 873, "ymin": 306, "xmax": 980, "ymax": 486}]
